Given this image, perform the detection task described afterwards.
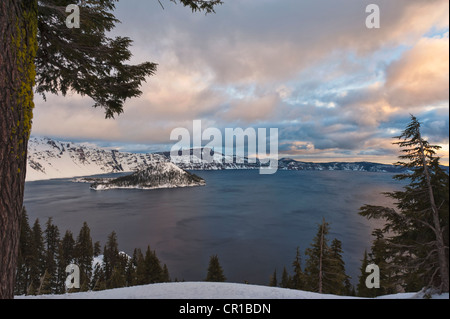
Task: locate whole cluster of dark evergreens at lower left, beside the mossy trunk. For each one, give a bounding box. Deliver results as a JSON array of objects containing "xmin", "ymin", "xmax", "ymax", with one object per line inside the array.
[{"xmin": 14, "ymin": 219, "xmax": 171, "ymax": 295}]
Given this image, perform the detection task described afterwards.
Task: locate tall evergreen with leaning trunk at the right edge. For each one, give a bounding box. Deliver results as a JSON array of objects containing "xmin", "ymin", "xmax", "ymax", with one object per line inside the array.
[{"xmin": 360, "ymin": 116, "xmax": 449, "ymax": 292}]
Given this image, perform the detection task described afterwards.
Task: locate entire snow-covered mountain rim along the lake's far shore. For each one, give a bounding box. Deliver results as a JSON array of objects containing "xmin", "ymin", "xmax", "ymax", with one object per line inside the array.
[{"xmin": 27, "ymin": 137, "xmax": 448, "ymax": 181}]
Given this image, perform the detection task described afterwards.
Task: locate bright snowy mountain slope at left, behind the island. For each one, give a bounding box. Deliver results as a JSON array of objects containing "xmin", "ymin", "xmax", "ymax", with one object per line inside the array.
[{"xmin": 26, "ymin": 138, "xmax": 167, "ymax": 181}]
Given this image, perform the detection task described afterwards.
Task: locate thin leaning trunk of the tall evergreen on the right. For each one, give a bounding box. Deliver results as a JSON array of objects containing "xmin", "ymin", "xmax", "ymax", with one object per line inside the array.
[{"xmin": 418, "ymin": 131, "xmax": 449, "ymax": 292}]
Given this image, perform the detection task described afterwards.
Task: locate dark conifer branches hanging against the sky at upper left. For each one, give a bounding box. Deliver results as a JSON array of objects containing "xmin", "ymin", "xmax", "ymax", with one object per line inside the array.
[{"xmin": 36, "ymin": 0, "xmax": 221, "ymax": 118}]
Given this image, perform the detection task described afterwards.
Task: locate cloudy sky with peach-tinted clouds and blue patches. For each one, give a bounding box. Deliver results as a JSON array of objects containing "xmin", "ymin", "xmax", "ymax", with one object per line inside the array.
[{"xmin": 29, "ymin": 0, "xmax": 449, "ymax": 164}]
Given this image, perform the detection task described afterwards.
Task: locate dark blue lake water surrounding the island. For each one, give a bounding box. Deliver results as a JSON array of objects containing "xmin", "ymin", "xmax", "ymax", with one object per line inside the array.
[{"xmin": 25, "ymin": 170, "xmax": 402, "ymax": 284}]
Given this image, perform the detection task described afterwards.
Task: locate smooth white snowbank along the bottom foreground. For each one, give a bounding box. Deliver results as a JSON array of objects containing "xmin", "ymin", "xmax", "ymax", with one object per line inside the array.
[{"xmin": 16, "ymin": 282, "xmax": 449, "ymax": 299}]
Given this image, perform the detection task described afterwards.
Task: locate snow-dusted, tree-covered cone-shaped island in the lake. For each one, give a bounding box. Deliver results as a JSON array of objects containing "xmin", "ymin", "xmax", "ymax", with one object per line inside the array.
[{"xmin": 85, "ymin": 162, "xmax": 206, "ymax": 190}]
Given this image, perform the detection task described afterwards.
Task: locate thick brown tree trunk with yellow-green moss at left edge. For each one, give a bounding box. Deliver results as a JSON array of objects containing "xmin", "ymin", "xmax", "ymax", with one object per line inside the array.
[{"xmin": 0, "ymin": 0, "xmax": 37, "ymax": 299}]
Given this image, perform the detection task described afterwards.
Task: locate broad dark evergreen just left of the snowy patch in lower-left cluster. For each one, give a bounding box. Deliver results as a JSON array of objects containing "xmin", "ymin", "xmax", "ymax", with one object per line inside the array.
[{"xmin": 75, "ymin": 222, "xmax": 94, "ymax": 287}]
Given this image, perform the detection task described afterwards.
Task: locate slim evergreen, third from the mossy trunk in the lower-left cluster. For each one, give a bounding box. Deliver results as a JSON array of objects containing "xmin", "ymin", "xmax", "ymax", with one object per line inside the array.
[{"xmin": 44, "ymin": 217, "xmax": 60, "ymax": 294}]
